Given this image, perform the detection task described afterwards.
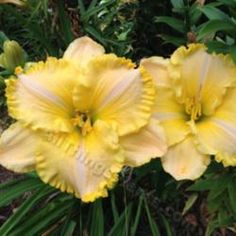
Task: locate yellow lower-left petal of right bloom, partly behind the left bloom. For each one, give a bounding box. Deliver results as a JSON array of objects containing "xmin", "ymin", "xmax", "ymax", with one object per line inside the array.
[{"xmin": 153, "ymin": 87, "xmax": 190, "ymax": 146}]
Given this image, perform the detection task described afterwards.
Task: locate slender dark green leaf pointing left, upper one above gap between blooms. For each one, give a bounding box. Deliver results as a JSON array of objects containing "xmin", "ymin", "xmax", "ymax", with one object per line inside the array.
[{"xmin": 155, "ymin": 16, "xmax": 186, "ymax": 33}]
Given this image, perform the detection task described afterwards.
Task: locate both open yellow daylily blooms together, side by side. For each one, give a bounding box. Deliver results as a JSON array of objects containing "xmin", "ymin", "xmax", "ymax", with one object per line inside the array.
[{"xmin": 0, "ymin": 37, "xmax": 236, "ymax": 202}]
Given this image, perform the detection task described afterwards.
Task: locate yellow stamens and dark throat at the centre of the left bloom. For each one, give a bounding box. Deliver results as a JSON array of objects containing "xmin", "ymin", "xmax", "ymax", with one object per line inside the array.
[{"xmin": 72, "ymin": 111, "xmax": 92, "ymax": 136}]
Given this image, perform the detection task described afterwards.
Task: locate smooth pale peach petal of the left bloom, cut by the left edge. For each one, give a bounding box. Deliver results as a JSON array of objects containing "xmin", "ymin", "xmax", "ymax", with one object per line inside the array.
[{"xmin": 0, "ymin": 122, "xmax": 38, "ymax": 173}]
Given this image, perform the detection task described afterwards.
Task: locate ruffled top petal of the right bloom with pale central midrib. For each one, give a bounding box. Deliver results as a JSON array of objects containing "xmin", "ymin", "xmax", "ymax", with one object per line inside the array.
[{"xmin": 169, "ymin": 44, "xmax": 236, "ymax": 116}]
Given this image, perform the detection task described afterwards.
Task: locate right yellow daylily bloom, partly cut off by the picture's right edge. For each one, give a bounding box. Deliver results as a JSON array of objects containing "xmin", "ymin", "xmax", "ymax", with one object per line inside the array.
[{"xmin": 141, "ymin": 44, "xmax": 236, "ymax": 180}]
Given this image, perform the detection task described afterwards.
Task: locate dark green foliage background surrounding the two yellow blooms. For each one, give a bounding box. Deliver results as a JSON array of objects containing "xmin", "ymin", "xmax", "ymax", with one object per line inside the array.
[{"xmin": 0, "ymin": 0, "xmax": 236, "ymax": 236}]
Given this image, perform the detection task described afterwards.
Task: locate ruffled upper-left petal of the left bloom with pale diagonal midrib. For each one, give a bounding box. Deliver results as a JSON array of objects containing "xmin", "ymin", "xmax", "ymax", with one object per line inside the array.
[{"xmin": 6, "ymin": 58, "xmax": 79, "ymax": 132}]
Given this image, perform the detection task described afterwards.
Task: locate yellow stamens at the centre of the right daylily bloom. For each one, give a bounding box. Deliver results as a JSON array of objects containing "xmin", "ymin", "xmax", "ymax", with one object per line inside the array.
[{"xmin": 185, "ymin": 97, "xmax": 202, "ymax": 120}]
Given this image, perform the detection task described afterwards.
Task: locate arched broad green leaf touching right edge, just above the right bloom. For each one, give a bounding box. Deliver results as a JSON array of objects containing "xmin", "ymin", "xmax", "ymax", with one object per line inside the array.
[{"xmin": 197, "ymin": 20, "xmax": 236, "ymax": 40}]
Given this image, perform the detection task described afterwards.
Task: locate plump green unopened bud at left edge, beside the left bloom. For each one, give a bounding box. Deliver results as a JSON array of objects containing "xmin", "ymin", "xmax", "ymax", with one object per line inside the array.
[{"xmin": 0, "ymin": 40, "xmax": 26, "ymax": 73}]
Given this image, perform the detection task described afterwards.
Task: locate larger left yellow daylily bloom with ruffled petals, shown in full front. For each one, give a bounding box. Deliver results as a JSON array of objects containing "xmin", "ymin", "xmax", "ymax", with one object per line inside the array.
[{"xmin": 0, "ymin": 37, "xmax": 167, "ymax": 202}]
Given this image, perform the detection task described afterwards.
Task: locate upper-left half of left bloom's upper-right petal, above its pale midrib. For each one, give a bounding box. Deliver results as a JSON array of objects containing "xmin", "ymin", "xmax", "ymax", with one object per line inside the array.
[{"xmin": 73, "ymin": 54, "xmax": 135, "ymax": 111}]
